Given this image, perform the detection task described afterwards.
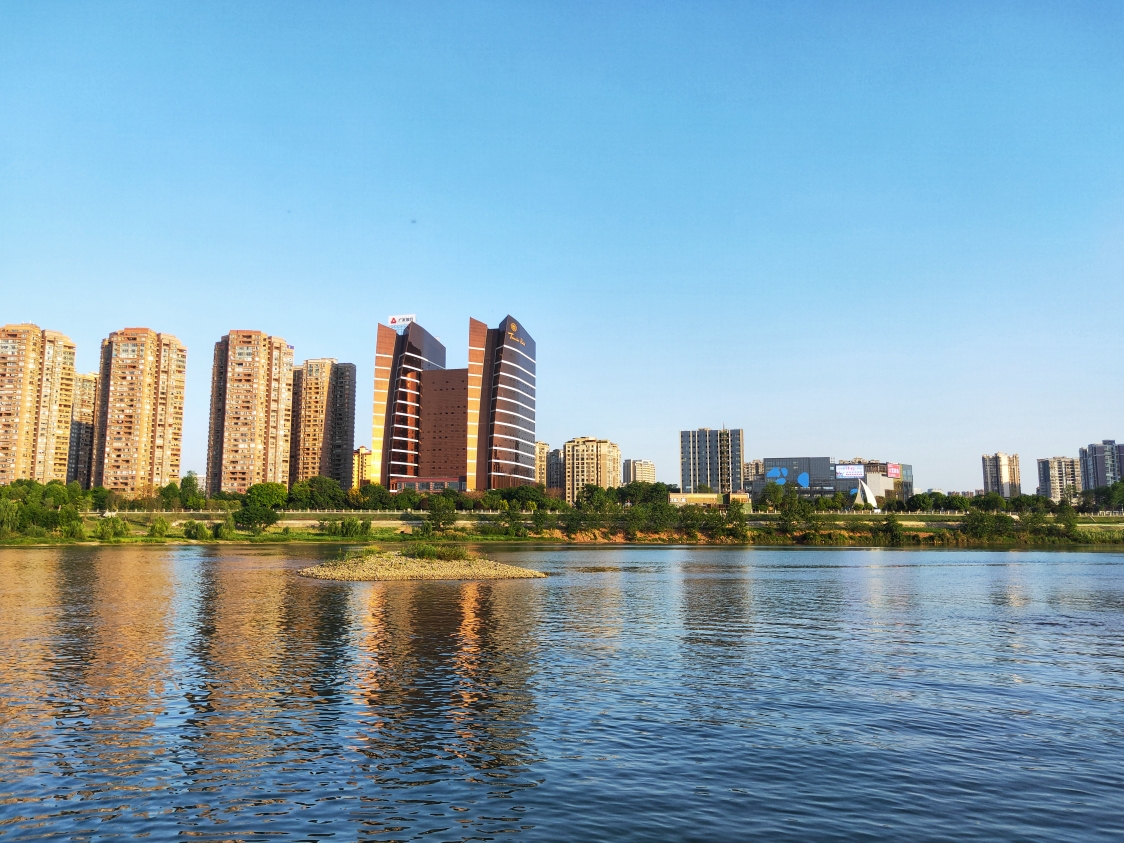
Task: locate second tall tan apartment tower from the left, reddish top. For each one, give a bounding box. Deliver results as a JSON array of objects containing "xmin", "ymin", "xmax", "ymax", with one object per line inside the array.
[{"xmin": 90, "ymin": 328, "xmax": 188, "ymax": 496}]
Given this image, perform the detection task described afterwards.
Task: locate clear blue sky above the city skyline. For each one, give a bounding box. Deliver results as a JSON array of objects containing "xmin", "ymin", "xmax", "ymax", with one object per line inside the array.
[{"xmin": 0, "ymin": 0, "xmax": 1124, "ymax": 491}]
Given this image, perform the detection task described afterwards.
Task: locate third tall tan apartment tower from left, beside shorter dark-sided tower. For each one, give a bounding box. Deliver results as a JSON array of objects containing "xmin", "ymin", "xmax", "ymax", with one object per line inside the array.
[{"xmin": 207, "ymin": 330, "xmax": 292, "ymax": 495}]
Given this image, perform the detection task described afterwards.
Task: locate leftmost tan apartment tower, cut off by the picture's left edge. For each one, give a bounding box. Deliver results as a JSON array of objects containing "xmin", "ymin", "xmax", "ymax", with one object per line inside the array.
[{"xmin": 0, "ymin": 324, "xmax": 75, "ymax": 483}]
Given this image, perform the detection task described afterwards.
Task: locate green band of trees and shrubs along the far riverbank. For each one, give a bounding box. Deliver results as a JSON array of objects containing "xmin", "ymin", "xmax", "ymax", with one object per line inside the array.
[{"xmin": 0, "ymin": 474, "xmax": 1124, "ymax": 546}]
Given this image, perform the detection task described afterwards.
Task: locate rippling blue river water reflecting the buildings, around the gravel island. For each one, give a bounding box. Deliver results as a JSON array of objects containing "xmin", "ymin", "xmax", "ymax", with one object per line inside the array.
[{"xmin": 0, "ymin": 546, "xmax": 1124, "ymax": 841}]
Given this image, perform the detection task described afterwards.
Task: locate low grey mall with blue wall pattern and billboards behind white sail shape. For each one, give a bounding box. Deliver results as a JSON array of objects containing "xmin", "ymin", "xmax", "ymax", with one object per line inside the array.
[{"xmin": 745, "ymin": 456, "xmax": 914, "ymax": 502}]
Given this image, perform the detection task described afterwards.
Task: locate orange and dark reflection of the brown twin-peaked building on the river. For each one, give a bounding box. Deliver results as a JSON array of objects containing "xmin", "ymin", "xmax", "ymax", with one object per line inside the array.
[{"xmin": 356, "ymin": 582, "xmax": 536, "ymax": 783}]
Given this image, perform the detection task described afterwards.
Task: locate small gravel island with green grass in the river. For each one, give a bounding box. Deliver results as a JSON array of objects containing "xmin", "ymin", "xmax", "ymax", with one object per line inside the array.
[{"xmin": 297, "ymin": 544, "xmax": 546, "ymax": 582}]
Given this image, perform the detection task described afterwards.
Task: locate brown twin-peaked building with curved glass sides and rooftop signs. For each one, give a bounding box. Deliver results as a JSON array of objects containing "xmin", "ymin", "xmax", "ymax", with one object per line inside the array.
[{"xmin": 372, "ymin": 316, "xmax": 536, "ymax": 491}]
